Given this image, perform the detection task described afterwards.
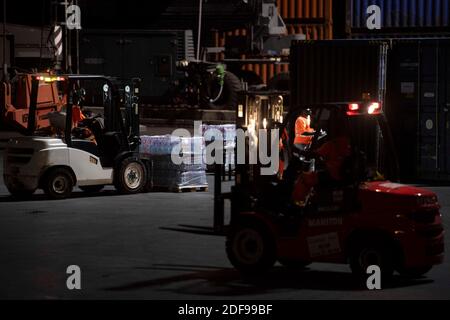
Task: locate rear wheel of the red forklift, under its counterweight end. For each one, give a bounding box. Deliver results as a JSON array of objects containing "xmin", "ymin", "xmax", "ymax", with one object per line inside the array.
[{"xmin": 350, "ymin": 238, "xmax": 395, "ymax": 282}]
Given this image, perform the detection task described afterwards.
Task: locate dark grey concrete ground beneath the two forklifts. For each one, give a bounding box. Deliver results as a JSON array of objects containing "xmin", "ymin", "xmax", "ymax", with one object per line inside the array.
[{"xmin": 0, "ymin": 150, "xmax": 450, "ymax": 300}]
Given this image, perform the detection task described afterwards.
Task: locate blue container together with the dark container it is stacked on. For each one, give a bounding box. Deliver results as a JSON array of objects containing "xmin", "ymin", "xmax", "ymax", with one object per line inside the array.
[{"xmin": 282, "ymin": 0, "xmax": 450, "ymax": 182}]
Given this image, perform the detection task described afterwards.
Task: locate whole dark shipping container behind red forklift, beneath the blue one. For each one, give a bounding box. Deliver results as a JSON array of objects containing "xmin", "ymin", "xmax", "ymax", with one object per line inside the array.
[{"xmin": 290, "ymin": 38, "xmax": 450, "ymax": 182}]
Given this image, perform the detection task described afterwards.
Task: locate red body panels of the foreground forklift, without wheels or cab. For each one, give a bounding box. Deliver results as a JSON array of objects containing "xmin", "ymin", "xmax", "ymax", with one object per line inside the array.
[{"xmin": 244, "ymin": 181, "xmax": 444, "ymax": 267}]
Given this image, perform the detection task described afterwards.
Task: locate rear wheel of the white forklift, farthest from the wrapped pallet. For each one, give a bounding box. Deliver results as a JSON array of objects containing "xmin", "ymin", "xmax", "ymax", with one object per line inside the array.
[{"xmin": 42, "ymin": 168, "xmax": 74, "ymax": 200}]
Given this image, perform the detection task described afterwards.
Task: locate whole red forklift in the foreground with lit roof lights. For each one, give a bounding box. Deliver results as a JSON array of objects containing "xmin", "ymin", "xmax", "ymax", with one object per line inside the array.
[{"xmin": 214, "ymin": 95, "xmax": 444, "ymax": 279}]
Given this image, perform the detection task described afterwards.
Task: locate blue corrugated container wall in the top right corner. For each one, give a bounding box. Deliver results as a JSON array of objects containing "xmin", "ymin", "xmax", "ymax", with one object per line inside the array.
[{"xmin": 347, "ymin": 0, "xmax": 450, "ymax": 36}]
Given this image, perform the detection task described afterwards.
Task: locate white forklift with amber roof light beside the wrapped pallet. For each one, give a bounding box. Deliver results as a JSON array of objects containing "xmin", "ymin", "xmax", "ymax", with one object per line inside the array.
[{"xmin": 4, "ymin": 75, "xmax": 148, "ymax": 199}]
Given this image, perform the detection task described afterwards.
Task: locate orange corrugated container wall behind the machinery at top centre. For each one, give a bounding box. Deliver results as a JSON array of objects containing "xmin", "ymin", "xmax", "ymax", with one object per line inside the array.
[{"xmin": 216, "ymin": 0, "xmax": 333, "ymax": 84}]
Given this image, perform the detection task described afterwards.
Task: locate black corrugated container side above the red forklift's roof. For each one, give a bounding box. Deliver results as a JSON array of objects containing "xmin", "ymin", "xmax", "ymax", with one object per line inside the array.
[{"xmin": 290, "ymin": 40, "xmax": 388, "ymax": 109}]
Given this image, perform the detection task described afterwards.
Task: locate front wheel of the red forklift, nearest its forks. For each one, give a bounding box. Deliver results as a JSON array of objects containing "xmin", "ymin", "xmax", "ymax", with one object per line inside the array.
[{"xmin": 226, "ymin": 221, "xmax": 276, "ymax": 275}]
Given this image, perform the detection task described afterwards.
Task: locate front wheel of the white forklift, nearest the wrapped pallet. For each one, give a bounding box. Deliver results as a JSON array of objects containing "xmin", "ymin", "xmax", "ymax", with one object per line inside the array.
[{"xmin": 114, "ymin": 157, "xmax": 147, "ymax": 194}]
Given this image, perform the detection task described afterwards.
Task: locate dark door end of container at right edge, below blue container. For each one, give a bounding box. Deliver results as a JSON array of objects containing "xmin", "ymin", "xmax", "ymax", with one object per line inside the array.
[{"xmin": 386, "ymin": 39, "xmax": 450, "ymax": 181}]
